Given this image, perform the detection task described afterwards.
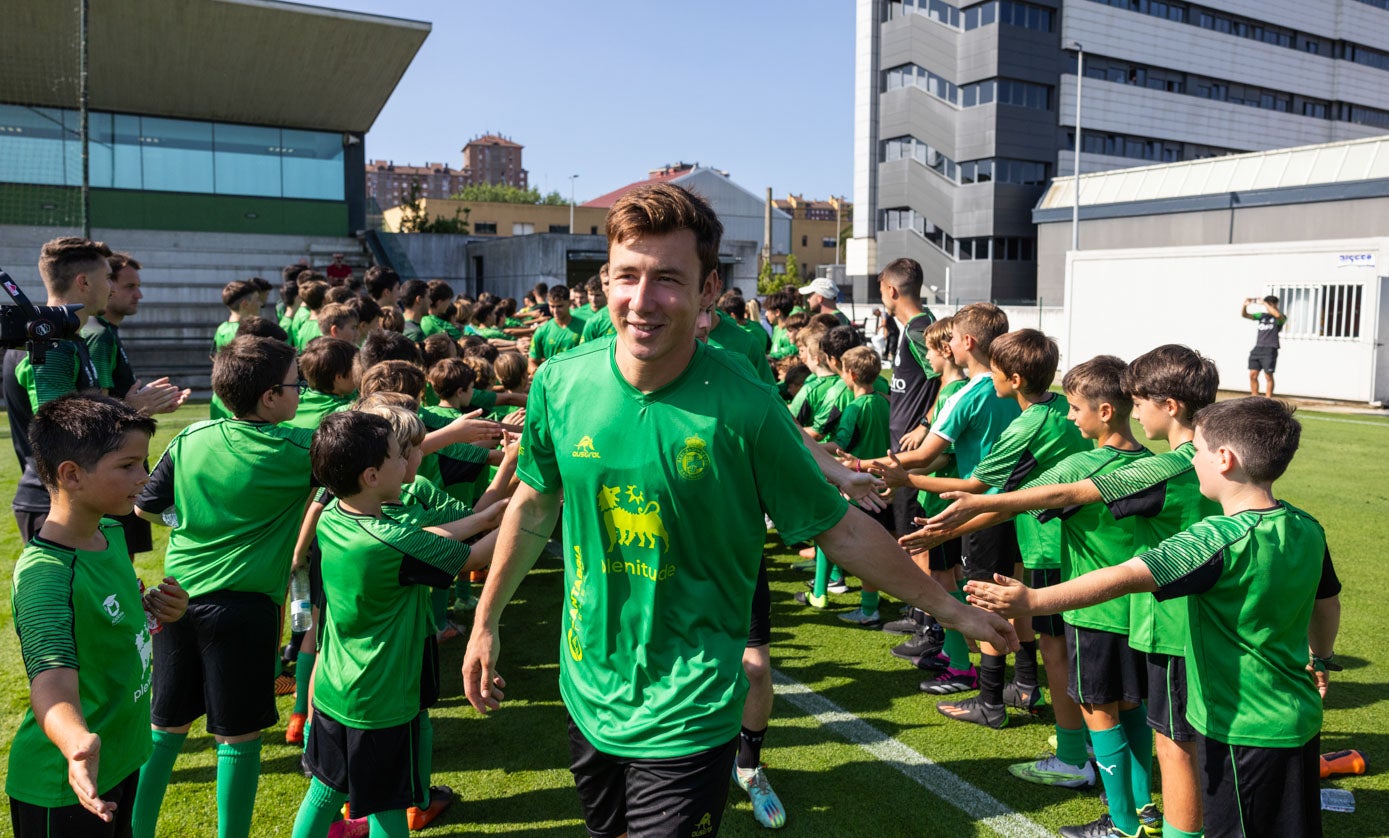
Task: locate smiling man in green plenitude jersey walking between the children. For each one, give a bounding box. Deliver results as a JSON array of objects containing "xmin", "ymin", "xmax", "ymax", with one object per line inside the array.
[{"xmin": 463, "ymin": 183, "xmax": 1015, "ymax": 838}]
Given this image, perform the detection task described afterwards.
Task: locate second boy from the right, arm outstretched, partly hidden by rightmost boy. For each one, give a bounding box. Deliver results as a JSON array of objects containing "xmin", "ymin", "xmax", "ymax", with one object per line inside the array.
[{"xmin": 931, "ymin": 345, "xmax": 1220, "ymax": 835}]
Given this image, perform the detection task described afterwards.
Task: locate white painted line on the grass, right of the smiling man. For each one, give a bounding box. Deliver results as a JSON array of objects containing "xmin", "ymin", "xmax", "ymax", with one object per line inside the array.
[{"xmin": 772, "ymin": 670, "xmax": 1051, "ymax": 838}]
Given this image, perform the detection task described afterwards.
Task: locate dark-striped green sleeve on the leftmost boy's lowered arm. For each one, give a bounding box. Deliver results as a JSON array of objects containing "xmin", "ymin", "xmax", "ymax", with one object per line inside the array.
[{"xmin": 14, "ymin": 553, "xmax": 78, "ymax": 681}]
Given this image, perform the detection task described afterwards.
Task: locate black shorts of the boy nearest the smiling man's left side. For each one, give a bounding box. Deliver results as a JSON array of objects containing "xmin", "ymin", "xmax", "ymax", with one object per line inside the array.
[{"xmin": 304, "ymin": 707, "xmax": 429, "ymax": 817}]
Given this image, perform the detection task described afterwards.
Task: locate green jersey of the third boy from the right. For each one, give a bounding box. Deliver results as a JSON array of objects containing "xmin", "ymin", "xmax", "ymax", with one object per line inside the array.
[{"xmin": 1018, "ymin": 447, "xmax": 1153, "ymax": 635}]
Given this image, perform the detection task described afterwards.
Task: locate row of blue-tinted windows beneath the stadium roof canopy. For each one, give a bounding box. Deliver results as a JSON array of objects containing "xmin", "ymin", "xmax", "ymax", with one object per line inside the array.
[{"xmin": 0, "ymin": 104, "xmax": 343, "ymax": 200}]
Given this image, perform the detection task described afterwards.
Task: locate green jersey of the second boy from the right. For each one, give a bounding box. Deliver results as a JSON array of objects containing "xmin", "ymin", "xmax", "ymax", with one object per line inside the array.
[{"xmin": 1090, "ymin": 442, "xmax": 1221, "ymax": 655}]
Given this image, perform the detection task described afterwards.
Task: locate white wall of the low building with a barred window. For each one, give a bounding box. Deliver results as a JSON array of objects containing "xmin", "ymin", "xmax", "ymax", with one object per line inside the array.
[{"xmin": 1061, "ymin": 239, "xmax": 1389, "ymax": 402}]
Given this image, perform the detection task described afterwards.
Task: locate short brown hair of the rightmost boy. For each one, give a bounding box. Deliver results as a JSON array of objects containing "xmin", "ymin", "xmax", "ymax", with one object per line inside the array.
[{"xmin": 1193, "ymin": 396, "xmax": 1301, "ymax": 484}]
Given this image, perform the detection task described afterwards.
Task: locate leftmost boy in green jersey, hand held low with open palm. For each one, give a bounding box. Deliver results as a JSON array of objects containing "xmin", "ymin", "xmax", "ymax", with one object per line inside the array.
[{"xmin": 6, "ymin": 396, "xmax": 188, "ymax": 838}]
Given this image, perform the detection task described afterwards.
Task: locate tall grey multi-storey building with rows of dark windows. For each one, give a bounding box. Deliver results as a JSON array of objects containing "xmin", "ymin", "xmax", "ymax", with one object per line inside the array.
[{"xmin": 846, "ymin": 0, "xmax": 1389, "ymax": 302}]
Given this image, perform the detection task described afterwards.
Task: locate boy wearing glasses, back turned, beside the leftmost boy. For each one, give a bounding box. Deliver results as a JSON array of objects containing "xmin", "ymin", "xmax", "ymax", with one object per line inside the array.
[{"xmin": 133, "ymin": 336, "xmax": 311, "ymax": 838}]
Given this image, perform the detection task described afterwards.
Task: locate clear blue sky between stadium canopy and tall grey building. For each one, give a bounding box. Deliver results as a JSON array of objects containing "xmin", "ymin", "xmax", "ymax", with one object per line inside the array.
[{"xmin": 298, "ymin": 0, "xmax": 854, "ymax": 203}]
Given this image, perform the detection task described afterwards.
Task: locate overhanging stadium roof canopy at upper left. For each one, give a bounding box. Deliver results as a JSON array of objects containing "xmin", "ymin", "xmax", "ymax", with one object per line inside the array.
[{"xmin": 0, "ymin": 0, "xmax": 431, "ymax": 132}]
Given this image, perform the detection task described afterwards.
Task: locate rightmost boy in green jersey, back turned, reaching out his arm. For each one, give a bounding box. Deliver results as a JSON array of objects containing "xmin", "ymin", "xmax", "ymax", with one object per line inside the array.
[{"xmin": 970, "ymin": 396, "xmax": 1340, "ymax": 837}]
